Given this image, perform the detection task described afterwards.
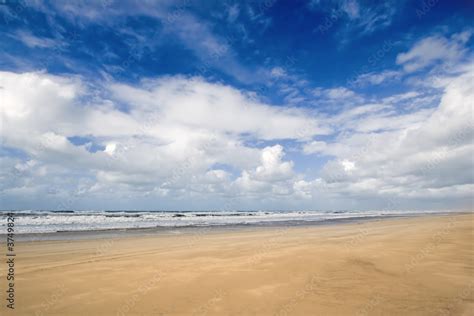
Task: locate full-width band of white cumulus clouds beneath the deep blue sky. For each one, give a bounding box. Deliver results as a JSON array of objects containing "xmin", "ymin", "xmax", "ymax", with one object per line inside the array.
[{"xmin": 0, "ymin": 33, "xmax": 474, "ymax": 208}]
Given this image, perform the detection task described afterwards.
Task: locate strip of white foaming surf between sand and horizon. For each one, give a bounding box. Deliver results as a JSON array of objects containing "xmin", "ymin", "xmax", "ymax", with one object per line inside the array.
[{"xmin": 0, "ymin": 210, "xmax": 452, "ymax": 234}]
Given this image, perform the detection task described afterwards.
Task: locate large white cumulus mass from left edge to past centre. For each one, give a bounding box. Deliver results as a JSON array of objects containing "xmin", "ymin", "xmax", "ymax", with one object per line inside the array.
[{"xmin": 0, "ymin": 72, "xmax": 327, "ymax": 206}]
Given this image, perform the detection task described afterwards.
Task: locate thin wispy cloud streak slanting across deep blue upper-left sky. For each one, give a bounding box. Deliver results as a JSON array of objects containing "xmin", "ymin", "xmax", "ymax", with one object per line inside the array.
[{"xmin": 27, "ymin": 1, "xmax": 267, "ymax": 83}]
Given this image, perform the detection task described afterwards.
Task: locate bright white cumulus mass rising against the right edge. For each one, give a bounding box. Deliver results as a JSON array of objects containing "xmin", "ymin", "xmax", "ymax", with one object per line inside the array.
[{"xmin": 305, "ymin": 65, "xmax": 474, "ymax": 206}]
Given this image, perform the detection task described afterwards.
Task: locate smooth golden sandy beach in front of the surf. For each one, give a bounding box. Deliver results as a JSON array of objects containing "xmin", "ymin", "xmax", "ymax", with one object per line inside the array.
[{"xmin": 0, "ymin": 214, "xmax": 474, "ymax": 315}]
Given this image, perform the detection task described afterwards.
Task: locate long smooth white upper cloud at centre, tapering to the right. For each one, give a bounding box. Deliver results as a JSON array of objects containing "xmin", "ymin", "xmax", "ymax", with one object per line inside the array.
[{"xmin": 111, "ymin": 77, "xmax": 328, "ymax": 140}]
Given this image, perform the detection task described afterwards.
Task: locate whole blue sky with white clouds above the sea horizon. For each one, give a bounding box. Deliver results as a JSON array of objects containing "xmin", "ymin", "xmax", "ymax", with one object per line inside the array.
[{"xmin": 0, "ymin": 0, "xmax": 474, "ymax": 210}]
